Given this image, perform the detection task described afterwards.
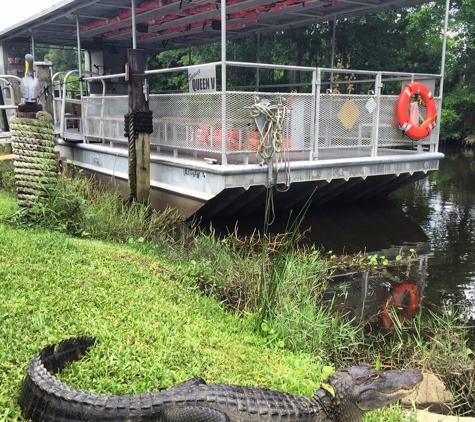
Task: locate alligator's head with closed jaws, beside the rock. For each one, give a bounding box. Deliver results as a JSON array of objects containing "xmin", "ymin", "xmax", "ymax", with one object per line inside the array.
[{"xmin": 317, "ymin": 364, "xmax": 422, "ymax": 422}]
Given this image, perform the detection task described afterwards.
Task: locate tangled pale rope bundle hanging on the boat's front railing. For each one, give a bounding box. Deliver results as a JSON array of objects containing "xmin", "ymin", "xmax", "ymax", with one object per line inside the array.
[{"xmin": 251, "ymin": 95, "xmax": 291, "ymax": 192}]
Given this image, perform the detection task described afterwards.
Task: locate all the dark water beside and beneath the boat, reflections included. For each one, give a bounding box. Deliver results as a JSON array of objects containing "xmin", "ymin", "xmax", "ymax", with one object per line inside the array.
[{"xmin": 213, "ymin": 149, "xmax": 475, "ymax": 343}]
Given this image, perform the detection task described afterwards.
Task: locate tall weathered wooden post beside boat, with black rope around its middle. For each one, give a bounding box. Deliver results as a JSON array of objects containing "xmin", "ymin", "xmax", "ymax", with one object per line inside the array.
[{"xmin": 127, "ymin": 48, "xmax": 150, "ymax": 203}]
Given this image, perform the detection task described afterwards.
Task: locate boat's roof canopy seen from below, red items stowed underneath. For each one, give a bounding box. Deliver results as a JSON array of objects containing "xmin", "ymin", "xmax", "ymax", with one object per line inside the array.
[{"xmin": 0, "ymin": 0, "xmax": 427, "ymax": 51}]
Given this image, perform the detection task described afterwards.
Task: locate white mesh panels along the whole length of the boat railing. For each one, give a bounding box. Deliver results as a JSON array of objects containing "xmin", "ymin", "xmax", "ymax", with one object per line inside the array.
[{"xmin": 74, "ymin": 64, "xmax": 441, "ymax": 162}]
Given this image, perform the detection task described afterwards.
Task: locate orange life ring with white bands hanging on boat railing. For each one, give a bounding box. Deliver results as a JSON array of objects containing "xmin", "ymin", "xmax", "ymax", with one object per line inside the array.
[{"xmin": 397, "ymin": 82, "xmax": 437, "ymax": 140}]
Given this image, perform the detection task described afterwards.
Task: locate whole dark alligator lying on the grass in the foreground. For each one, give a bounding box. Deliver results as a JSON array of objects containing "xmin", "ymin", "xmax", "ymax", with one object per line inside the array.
[{"xmin": 19, "ymin": 337, "xmax": 422, "ymax": 422}]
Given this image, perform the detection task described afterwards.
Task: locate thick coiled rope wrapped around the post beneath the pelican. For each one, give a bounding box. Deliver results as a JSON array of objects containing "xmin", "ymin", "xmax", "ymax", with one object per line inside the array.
[{"xmin": 10, "ymin": 111, "xmax": 57, "ymax": 208}]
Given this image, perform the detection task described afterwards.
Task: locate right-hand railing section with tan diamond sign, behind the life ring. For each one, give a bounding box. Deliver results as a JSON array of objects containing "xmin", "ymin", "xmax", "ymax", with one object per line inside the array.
[{"xmin": 314, "ymin": 68, "xmax": 442, "ymax": 159}]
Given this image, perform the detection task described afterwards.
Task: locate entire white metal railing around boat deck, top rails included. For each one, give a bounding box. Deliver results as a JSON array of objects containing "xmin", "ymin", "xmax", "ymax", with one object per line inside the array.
[{"xmin": 58, "ymin": 62, "xmax": 441, "ymax": 164}]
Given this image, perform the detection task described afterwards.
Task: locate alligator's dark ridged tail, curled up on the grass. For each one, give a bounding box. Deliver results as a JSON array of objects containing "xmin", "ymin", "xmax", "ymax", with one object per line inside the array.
[{"xmin": 19, "ymin": 337, "xmax": 165, "ymax": 422}]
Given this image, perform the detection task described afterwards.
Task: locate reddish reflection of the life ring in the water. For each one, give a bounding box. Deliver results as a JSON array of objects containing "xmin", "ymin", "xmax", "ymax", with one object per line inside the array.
[{"xmin": 381, "ymin": 282, "xmax": 421, "ymax": 330}]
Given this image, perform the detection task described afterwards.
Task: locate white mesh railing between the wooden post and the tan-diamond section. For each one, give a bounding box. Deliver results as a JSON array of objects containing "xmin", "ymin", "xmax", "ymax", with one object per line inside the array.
[{"xmin": 150, "ymin": 92, "xmax": 314, "ymax": 154}]
